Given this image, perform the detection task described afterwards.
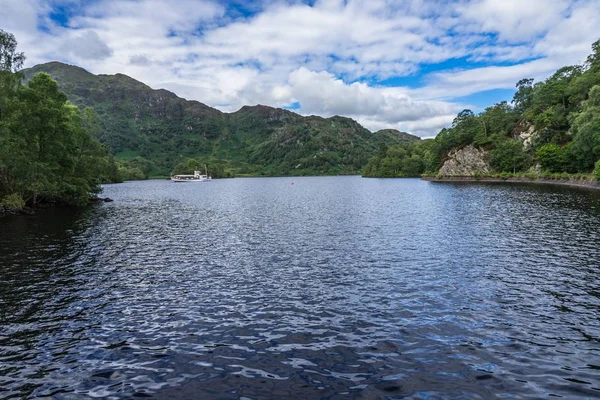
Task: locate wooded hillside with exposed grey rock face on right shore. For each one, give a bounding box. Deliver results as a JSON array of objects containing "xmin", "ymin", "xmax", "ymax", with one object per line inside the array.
[{"xmin": 364, "ymin": 40, "xmax": 600, "ymax": 180}]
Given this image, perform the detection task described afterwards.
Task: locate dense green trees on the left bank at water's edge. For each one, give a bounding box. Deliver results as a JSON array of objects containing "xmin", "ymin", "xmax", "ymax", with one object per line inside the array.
[{"xmin": 0, "ymin": 32, "xmax": 114, "ymax": 206}]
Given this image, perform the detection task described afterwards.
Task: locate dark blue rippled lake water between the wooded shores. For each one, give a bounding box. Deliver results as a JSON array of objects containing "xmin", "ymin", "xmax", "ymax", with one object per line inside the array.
[{"xmin": 0, "ymin": 177, "xmax": 600, "ymax": 399}]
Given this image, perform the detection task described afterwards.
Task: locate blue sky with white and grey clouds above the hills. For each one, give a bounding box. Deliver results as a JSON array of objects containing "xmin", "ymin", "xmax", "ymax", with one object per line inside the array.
[{"xmin": 0, "ymin": 0, "xmax": 600, "ymax": 137}]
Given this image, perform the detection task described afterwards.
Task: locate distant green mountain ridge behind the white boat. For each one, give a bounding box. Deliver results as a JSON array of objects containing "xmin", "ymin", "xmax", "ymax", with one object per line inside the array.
[{"xmin": 23, "ymin": 62, "xmax": 419, "ymax": 178}]
